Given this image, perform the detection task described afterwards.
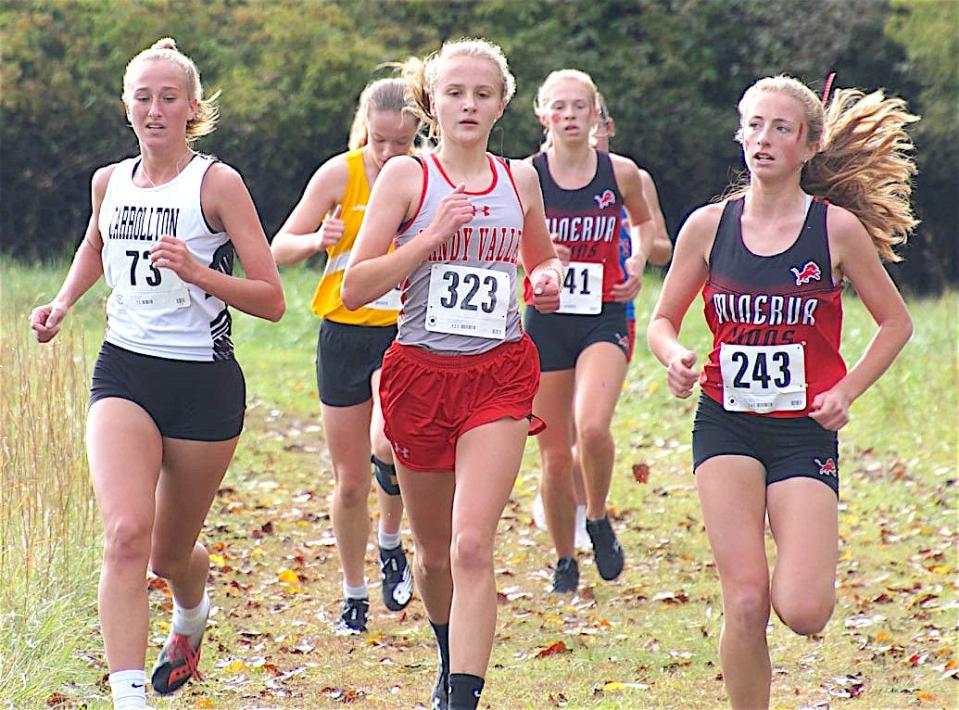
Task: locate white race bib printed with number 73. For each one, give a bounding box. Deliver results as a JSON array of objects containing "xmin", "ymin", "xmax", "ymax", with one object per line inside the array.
[{"xmin": 110, "ymin": 240, "xmax": 190, "ymax": 310}]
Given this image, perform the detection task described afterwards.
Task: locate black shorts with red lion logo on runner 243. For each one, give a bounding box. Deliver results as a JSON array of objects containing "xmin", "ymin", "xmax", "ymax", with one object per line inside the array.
[{"xmin": 693, "ymin": 394, "xmax": 839, "ymax": 496}]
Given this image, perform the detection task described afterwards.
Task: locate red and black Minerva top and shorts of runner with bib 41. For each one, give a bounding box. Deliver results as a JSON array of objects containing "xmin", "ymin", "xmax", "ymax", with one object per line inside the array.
[{"xmin": 524, "ymin": 150, "xmax": 629, "ymax": 372}]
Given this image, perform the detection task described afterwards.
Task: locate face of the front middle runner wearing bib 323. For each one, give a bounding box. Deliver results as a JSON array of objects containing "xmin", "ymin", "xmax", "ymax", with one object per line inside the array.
[{"xmin": 433, "ymin": 55, "xmax": 506, "ymax": 146}]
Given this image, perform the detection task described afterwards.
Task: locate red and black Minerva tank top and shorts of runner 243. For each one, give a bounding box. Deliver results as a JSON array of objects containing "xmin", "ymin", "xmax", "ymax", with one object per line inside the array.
[{"xmin": 693, "ymin": 193, "xmax": 846, "ymax": 496}]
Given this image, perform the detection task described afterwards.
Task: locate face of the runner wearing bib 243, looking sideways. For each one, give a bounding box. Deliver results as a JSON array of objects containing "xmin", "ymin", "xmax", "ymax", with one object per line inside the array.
[{"xmin": 741, "ymin": 91, "xmax": 815, "ymax": 179}]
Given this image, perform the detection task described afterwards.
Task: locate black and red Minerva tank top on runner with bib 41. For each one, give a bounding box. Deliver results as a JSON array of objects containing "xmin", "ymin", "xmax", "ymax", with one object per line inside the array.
[{"xmin": 523, "ymin": 150, "xmax": 626, "ymax": 314}]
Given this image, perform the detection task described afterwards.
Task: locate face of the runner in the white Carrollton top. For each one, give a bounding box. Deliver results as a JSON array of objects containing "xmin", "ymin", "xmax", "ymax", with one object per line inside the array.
[{"xmin": 127, "ymin": 60, "xmax": 197, "ymax": 149}]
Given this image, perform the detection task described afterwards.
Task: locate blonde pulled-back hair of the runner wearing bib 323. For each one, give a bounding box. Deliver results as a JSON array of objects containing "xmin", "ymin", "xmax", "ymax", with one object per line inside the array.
[{"xmin": 402, "ymin": 37, "xmax": 516, "ymax": 146}]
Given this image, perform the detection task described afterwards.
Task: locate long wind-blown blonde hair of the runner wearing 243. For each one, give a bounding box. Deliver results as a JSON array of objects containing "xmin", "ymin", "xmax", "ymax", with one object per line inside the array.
[{"xmin": 731, "ymin": 74, "xmax": 919, "ymax": 261}]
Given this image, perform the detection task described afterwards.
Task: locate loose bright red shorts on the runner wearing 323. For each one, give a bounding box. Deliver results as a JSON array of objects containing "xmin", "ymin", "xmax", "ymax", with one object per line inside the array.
[{"xmin": 380, "ymin": 335, "xmax": 541, "ymax": 471}]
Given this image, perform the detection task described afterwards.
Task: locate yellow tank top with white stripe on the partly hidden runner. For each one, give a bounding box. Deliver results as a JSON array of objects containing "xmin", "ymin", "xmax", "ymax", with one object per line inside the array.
[{"xmin": 313, "ymin": 148, "xmax": 399, "ymax": 325}]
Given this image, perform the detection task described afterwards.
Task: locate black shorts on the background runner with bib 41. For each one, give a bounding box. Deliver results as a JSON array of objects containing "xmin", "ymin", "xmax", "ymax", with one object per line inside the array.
[{"xmin": 523, "ymin": 301, "xmax": 630, "ymax": 372}]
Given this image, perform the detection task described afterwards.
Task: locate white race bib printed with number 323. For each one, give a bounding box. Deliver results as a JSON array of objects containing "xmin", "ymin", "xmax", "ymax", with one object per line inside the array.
[{"xmin": 426, "ymin": 264, "xmax": 510, "ymax": 340}]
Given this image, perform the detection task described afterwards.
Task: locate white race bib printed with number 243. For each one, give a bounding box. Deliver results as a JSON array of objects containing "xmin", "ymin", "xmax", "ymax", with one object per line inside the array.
[{"xmin": 719, "ymin": 343, "xmax": 806, "ymax": 414}]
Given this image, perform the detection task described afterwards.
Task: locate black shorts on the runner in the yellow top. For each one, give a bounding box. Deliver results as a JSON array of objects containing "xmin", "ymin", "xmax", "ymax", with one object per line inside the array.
[{"xmin": 316, "ymin": 320, "xmax": 396, "ymax": 407}]
